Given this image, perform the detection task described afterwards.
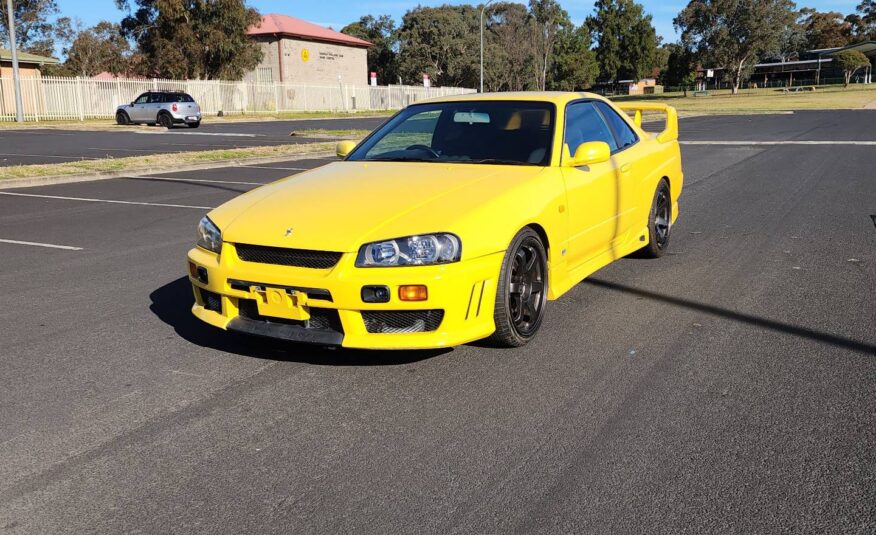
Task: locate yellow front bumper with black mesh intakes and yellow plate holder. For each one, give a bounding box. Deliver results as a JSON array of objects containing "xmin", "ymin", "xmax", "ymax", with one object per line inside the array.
[{"xmin": 188, "ymin": 243, "xmax": 504, "ymax": 349}]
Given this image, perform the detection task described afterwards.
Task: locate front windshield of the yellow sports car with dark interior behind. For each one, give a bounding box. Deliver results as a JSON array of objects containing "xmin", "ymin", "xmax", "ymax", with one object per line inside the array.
[{"xmin": 347, "ymin": 101, "xmax": 554, "ymax": 166}]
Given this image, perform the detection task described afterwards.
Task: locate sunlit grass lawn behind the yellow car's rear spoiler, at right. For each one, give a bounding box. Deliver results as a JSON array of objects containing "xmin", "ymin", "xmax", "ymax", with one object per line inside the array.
[{"xmin": 612, "ymin": 84, "xmax": 876, "ymax": 115}]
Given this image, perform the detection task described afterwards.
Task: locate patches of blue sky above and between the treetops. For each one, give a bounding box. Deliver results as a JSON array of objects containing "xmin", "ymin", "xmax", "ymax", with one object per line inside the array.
[{"xmin": 58, "ymin": 0, "xmax": 859, "ymax": 42}]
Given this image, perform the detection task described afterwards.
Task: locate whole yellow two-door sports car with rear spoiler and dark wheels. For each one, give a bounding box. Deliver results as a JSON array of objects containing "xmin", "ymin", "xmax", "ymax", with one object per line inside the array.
[{"xmin": 188, "ymin": 93, "xmax": 684, "ymax": 349}]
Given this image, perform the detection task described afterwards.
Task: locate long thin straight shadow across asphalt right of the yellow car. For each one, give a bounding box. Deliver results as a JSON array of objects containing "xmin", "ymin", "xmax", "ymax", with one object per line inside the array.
[{"xmin": 582, "ymin": 278, "xmax": 876, "ymax": 355}]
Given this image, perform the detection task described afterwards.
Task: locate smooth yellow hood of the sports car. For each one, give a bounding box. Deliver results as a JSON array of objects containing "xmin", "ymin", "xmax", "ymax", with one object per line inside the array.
[{"xmin": 210, "ymin": 162, "xmax": 543, "ymax": 252}]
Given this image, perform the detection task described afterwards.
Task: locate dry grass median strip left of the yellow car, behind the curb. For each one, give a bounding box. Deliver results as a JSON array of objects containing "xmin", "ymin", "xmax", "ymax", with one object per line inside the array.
[{"xmin": 0, "ymin": 142, "xmax": 335, "ymax": 181}]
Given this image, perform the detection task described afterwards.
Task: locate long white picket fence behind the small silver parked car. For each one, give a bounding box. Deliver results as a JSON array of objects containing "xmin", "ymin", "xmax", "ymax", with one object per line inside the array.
[{"xmin": 0, "ymin": 76, "xmax": 475, "ymax": 121}]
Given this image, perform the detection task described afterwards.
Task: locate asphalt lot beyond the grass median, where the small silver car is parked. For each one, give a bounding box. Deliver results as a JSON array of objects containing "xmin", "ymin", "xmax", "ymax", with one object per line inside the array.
[{"xmin": 0, "ymin": 117, "xmax": 386, "ymax": 167}]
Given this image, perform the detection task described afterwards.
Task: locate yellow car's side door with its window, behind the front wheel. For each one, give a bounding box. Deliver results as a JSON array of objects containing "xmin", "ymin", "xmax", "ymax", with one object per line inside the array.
[{"xmin": 563, "ymin": 100, "xmax": 620, "ymax": 269}]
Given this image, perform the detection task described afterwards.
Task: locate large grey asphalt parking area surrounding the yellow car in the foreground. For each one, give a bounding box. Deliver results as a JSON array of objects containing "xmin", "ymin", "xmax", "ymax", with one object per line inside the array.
[{"xmin": 0, "ymin": 111, "xmax": 876, "ymax": 533}]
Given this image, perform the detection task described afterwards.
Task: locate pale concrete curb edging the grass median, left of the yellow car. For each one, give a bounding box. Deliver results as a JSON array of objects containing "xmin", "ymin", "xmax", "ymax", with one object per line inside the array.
[{"xmin": 0, "ymin": 151, "xmax": 335, "ymax": 190}]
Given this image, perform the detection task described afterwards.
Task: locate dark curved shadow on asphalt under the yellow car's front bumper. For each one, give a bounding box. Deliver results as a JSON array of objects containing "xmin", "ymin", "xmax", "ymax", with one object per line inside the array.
[{"xmin": 149, "ymin": 277, "xmax": 452, "ymax": 366}]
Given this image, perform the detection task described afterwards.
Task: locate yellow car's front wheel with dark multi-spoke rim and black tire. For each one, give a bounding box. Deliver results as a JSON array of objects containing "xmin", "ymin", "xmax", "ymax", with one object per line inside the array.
[{"xmin": 488, "ymin": 227, "xmax": 547, "ymax": 347}]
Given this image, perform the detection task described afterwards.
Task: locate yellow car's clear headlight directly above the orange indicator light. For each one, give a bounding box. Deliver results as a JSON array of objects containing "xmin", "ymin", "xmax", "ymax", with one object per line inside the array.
[{"xmin": 356, "ymin": 233, "xmax": 462, "ymax": 267}]
